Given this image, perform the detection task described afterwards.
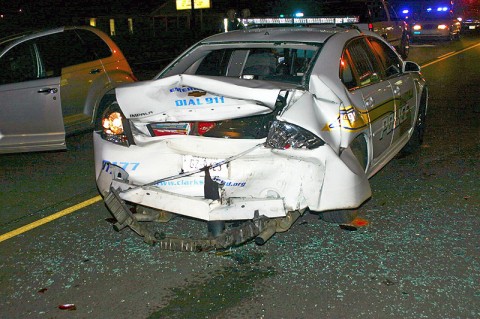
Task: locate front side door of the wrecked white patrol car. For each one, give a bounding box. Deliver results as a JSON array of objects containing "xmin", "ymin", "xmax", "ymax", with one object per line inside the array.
[{"xmin": 369, "ymin": 38, "xmax": 416, "ymax": 146}]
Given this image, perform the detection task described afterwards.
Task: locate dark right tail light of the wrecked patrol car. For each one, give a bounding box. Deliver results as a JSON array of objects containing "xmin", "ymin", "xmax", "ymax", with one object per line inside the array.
[{"xmin": 266, "ymin": 121, "xmax": 325, "ymax": 150}]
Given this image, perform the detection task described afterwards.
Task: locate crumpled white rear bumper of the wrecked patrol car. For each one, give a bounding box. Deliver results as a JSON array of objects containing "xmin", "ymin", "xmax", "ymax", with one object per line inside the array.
[{"xmin": 94, "ymin": 136, "xmax": 371, "ymax": 221}]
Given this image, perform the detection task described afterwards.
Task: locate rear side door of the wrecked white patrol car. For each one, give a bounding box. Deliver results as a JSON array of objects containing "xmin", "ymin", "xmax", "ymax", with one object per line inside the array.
[{"xmin": 343, "ymin": 37, "xmax": 395, "ymax": 169}]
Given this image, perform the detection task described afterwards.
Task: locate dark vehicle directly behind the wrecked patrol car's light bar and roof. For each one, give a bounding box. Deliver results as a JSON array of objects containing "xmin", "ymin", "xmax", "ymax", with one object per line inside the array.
[{"xmin": 320, "ymin": 0, "xmax": 410, "ymax": 59}]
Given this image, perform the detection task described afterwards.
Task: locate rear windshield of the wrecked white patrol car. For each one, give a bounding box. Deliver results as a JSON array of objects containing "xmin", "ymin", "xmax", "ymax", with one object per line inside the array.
[{"xmin": 160, "ymin": 43, "xmax": 320, "ymax": 84}]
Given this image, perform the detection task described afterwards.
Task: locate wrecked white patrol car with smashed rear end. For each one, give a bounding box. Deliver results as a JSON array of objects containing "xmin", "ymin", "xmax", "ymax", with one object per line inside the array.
[{"xmin": 94, "ymin": 19, "xmax": 428, "ymax": 250}]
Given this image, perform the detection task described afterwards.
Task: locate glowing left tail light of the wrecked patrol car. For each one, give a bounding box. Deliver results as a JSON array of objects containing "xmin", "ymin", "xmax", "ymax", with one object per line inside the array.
[{"xmin": 95, "ymin": 103, "xmax": 134, "ymax": 146}]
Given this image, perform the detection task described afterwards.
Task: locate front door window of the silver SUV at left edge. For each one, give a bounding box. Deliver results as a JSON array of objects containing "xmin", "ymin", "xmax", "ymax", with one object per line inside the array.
[{"xmin": 0, "ymin": 41, "xmax": 39, "ymax": 84}]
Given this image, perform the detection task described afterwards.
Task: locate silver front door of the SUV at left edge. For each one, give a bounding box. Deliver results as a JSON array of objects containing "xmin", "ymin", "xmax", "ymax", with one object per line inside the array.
[{"xmin": 0, "ymin": 40, "xmax": 65, "ymax": 153}]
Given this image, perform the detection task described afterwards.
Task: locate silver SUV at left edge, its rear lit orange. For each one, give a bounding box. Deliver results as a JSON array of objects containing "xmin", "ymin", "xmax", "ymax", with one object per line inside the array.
[{"xmin": 0, "ymin": 26, "xmax": 134, "ymax": 153}]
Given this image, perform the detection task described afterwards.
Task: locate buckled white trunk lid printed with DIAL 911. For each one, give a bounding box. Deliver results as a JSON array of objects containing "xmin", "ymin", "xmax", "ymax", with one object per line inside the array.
[{"xmin": 116, "ymin": 74, "xmax": 297, "ymax": 123}]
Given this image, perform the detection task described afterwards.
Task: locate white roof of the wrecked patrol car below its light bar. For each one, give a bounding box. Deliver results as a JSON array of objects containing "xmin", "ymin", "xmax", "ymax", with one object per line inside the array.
[{"xmin": 201, "ymin": 26, "xmax": 360, "ymax": 44}]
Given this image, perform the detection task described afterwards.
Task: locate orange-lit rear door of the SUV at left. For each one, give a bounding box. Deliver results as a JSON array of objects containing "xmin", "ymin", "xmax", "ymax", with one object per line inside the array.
[{"xmin": 37, "ymin": 30, "xmax": 108, "ymax": 133}]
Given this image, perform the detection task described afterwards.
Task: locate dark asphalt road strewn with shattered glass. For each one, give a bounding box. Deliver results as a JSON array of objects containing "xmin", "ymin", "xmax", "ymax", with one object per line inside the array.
[{"xmin": 0, "ymin": 38, "xmax": 480, "ymax": 319}]
